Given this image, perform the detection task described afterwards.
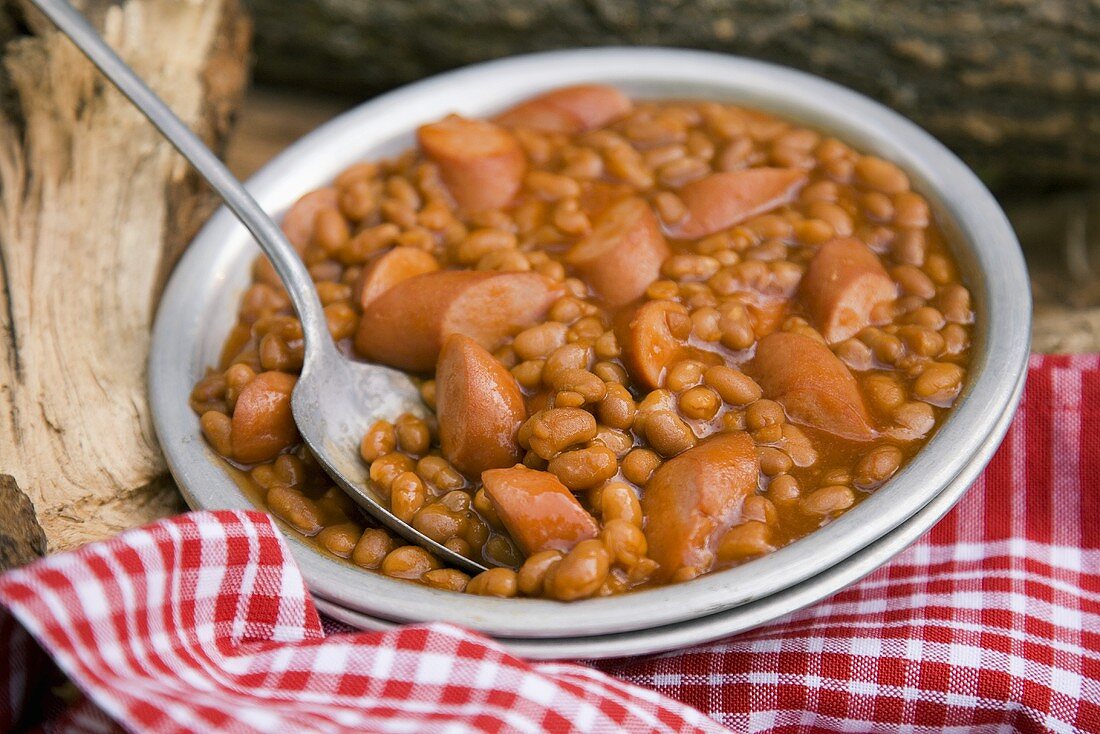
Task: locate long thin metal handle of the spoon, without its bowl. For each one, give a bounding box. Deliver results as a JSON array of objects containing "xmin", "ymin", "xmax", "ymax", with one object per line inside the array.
[{"xmin": 31, "ymin": 0, "xmax": 333, "ymax": 354}]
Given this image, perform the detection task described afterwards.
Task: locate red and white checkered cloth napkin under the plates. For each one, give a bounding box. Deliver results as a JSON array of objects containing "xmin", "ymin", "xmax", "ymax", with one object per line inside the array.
[{"xmin": 0, "ymin": 357, "xmax": 1100, "ymax": 733}]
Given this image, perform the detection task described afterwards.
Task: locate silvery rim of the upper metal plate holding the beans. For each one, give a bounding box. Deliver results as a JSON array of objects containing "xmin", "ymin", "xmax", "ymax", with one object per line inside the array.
[{"xmin": 150, "ymin": 48, "xmax": 1031, "ymax": 637}]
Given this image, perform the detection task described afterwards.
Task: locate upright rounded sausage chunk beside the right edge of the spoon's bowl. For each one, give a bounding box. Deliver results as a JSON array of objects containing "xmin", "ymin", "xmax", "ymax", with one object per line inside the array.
[{"xmin": 436, "ymin": 333, "xmax": 527, "ymax": 478}]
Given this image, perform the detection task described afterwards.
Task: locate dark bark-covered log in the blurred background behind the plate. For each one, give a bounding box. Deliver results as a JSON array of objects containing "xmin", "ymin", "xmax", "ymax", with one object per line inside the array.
[{"xmin": 250, "ymin": 0, "xmax": 1100, "ymax": 186}]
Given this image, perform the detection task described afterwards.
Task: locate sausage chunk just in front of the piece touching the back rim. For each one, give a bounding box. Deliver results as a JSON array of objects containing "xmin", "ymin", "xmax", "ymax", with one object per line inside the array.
[{"xmin": 417, "ymin": 114, "xmax": 527, "ymax": 211}]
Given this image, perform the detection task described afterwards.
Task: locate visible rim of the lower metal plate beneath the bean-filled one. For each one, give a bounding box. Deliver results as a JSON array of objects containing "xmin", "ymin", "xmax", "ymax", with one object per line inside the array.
[{"xmin": 315, "ymin": 360, "xmax": 1024, "ymax": 660}]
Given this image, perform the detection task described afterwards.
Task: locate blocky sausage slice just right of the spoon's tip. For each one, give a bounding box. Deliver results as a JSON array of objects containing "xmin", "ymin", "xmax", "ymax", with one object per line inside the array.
[{"xmin": 482, "ymin": 465, "xmax": 600, "ymax": 556}]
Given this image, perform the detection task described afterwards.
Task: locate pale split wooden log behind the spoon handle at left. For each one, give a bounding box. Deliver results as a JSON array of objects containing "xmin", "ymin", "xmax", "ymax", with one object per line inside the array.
[{"xmin": 0, "ymin": 0, "xmax": 250, "ymax": 550}]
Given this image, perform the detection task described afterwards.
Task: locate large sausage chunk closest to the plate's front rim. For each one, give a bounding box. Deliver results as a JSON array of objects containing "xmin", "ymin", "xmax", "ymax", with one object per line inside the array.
[{"xmin": 641, "ymin": 431, "xmax": 760, "ymax": 581}]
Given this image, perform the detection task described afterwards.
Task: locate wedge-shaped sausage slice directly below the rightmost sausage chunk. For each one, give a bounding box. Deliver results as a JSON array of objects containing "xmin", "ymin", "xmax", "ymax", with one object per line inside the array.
[{"xmin": 744, "ymin": 331, "xmax": 876, "ymax": 441}]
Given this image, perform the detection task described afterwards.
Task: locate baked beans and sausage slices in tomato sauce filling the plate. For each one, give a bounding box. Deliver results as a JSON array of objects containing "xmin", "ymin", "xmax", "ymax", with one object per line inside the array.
[{"xmin": 190, "ymin": 85, "xmax": 974, "ymax": 601}]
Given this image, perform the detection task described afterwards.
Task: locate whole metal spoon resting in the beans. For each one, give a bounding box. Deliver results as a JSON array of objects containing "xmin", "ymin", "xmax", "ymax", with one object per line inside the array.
[{"xmin": 32, "ymin": 0, "xmax": 485, "ymax": 573}]
